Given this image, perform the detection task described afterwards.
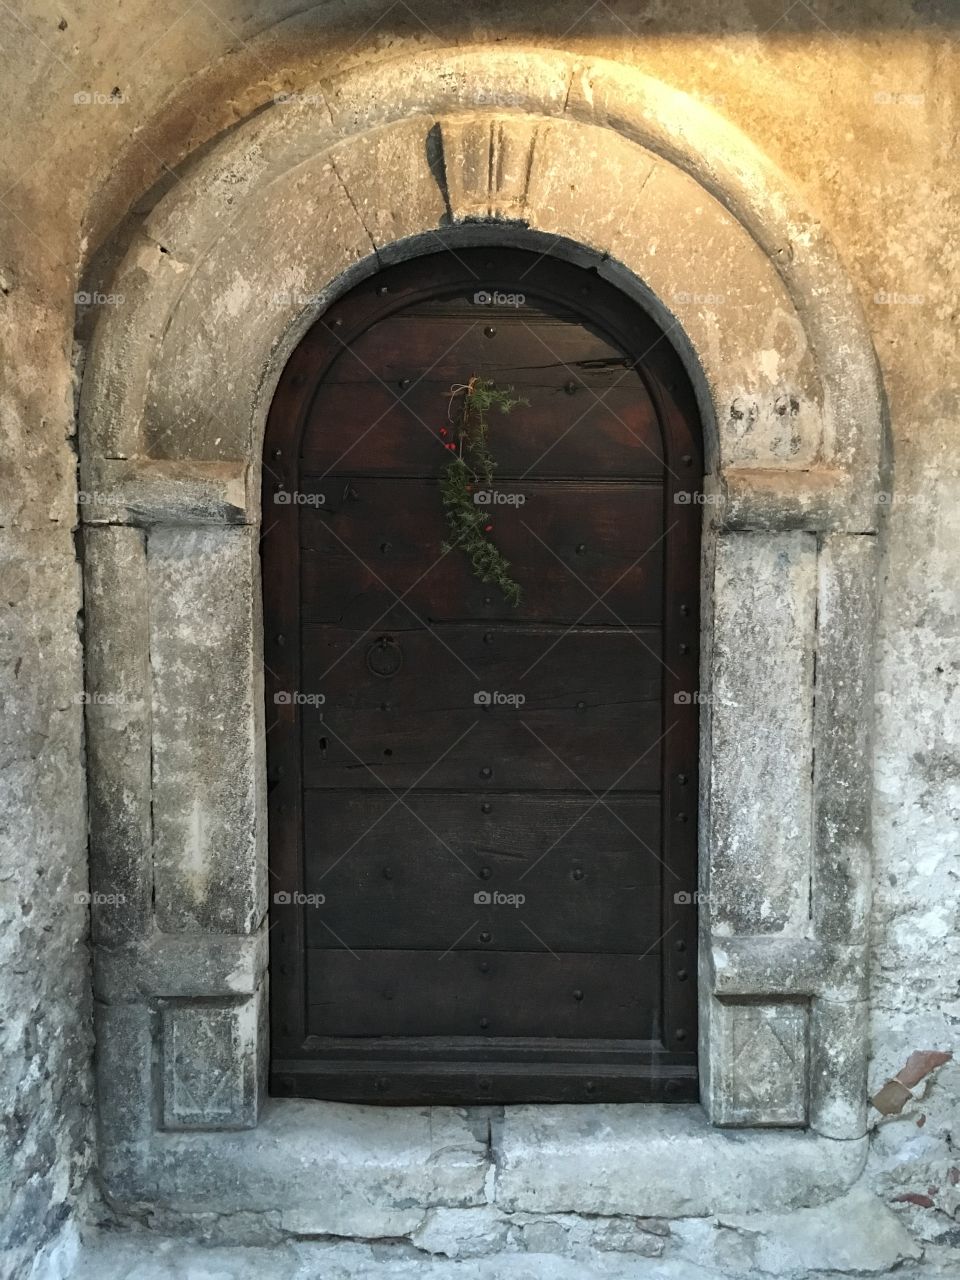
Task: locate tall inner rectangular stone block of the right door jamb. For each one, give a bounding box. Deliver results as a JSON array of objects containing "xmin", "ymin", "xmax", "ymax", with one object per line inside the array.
[{"xmin": 704, "ymin": 532, "xmax": 817, "ymax": 934}]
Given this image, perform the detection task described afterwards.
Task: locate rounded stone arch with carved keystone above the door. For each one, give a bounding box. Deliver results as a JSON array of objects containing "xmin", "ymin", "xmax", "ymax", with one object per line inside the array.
[{"xmin": 81, "ymin": 47, "xmax": 881, "ymax": 527}]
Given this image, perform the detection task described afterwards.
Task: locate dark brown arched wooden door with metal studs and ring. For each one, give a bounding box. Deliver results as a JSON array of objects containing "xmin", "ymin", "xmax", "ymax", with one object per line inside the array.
[{"xmin": 262, "ymin": 250, "xmax": 703, "ymax": 1102}]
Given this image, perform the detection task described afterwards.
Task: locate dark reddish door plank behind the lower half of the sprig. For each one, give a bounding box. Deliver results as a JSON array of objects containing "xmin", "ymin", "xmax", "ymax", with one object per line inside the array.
[{"xmin": 301, "ymin": 477, "xmax": 663, "ymax": 626}]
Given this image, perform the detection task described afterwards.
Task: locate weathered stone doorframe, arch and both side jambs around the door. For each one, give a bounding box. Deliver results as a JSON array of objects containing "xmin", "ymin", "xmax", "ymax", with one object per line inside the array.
[{"xmin": 79, "ymin": 45, "xmax": 882, "ymax": 1212}]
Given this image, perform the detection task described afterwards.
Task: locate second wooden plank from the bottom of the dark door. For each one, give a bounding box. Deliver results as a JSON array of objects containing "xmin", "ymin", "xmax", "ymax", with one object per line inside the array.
[{"xmin": 303, "ymin": 791, "xmax": 660, "ymax": 952}]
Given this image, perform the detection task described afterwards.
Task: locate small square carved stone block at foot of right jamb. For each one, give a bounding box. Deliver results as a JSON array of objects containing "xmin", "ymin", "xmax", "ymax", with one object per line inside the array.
[{"xmin": 710, "ymin": 1001, "xmax": 808, "ymax": 1125}]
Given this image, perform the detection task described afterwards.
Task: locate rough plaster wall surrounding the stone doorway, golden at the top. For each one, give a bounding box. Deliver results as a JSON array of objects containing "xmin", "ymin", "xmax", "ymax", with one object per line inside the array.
[{"xmin": 0, "ymin": 0, "xmax": 960, "ymax": 1276}]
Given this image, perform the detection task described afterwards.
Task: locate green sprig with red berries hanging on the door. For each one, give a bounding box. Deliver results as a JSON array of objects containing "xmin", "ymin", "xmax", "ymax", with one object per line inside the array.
[{"xmin": 439, "ymin": 376, "xmax": 529, "ymax": 608}]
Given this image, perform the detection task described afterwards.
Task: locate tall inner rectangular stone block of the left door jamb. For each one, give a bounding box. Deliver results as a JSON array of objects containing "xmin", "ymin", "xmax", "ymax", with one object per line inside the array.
[{"xmin": 148, "ymin": 527, "xmax": 266, "ymax": 933}]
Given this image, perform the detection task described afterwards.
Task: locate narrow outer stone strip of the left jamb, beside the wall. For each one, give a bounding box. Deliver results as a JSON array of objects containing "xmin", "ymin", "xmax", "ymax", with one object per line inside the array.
[{"xmin": 83, "ymin": 527, "xmax": 152, "ymax": 943}]
